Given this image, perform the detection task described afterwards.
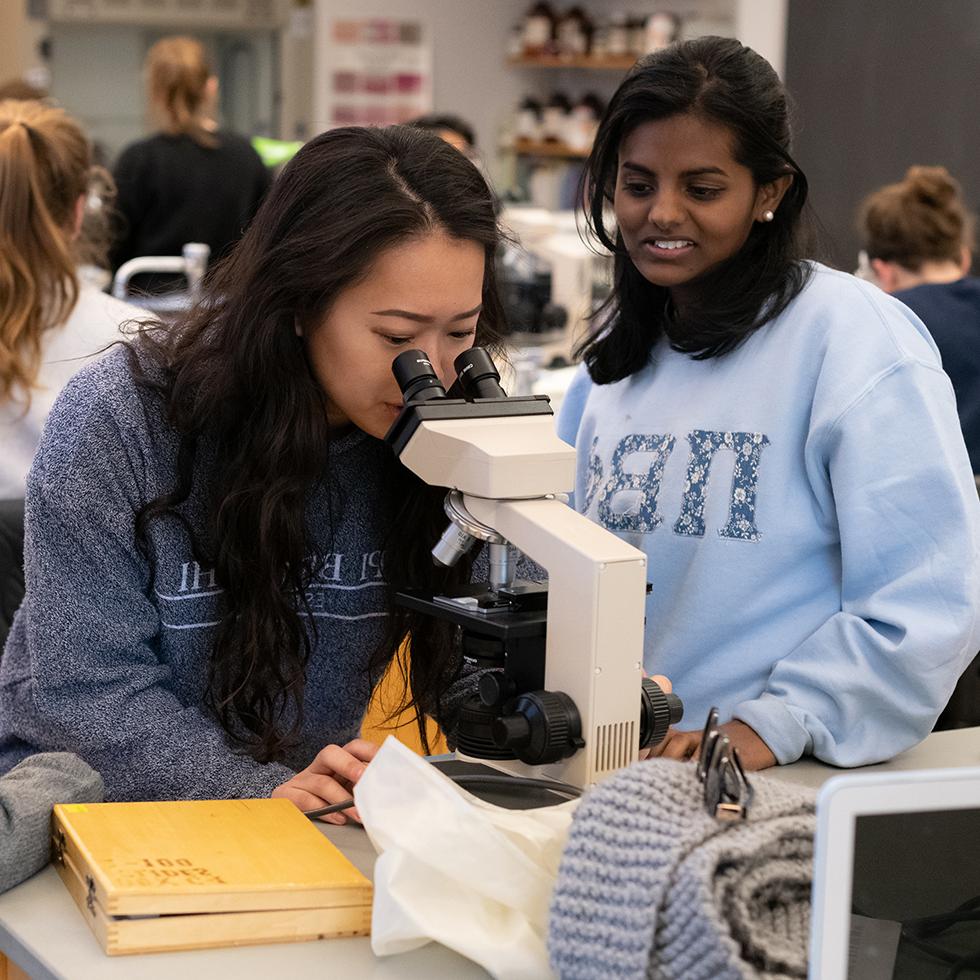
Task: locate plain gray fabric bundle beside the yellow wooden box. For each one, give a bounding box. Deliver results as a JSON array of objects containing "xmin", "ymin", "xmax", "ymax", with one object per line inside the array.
[{"xmin": 0, "ymin": 752, "xmax": 103, "ymax": 892}]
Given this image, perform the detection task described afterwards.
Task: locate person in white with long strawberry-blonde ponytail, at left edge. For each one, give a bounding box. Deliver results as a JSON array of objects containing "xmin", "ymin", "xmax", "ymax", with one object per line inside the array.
[{"xmin": 0, "ymin": 99, "xmax": 142, "ymax": 499}]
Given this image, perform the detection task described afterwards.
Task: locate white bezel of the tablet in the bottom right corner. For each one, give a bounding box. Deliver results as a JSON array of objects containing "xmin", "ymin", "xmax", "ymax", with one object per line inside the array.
[{"xmin": 808, "ymin": 766, "xmax": 980, "ymax": 980}]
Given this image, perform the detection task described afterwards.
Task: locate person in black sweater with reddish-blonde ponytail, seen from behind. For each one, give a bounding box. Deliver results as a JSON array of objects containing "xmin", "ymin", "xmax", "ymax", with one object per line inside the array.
[{"xmin": 112, "ymin": 37, "xmax": 271, "ymax": 289}]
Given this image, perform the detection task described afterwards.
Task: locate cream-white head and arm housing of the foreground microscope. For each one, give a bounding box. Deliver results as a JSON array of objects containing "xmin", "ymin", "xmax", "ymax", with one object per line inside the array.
[{"xmin": 389, "ymin": 350, "xmax": 679, "ymax": 787}]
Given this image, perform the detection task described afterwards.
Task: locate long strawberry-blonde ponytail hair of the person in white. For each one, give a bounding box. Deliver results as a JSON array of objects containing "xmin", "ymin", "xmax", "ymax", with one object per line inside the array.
[{"xmin": 0, "ymin": 99, "xmax": 91, "ymax": 402}]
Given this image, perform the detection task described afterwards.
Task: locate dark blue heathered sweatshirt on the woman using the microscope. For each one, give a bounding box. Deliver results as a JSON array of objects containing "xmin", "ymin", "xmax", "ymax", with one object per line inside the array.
[{"xmin": 0, "ymin": 349, "xmax": 474, "ymax": 800}]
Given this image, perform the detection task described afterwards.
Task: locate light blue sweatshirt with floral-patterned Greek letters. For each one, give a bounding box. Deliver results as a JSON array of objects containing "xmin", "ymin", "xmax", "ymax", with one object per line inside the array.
[{"xmin": 558, "ymin": 265, "xmax": 980, "ymax": 766}]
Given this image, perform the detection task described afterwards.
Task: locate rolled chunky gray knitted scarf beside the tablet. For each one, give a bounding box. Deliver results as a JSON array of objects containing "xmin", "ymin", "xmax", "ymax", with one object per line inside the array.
[{"xmin": 548, "ymin": 759, "xmax": 815, "ymax": 980}]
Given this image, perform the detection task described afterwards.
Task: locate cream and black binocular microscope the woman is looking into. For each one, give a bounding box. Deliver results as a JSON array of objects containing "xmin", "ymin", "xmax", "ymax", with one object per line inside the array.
[{"xmin": 385, "ymin": 347, "xmax": 683, "ymax": 788}]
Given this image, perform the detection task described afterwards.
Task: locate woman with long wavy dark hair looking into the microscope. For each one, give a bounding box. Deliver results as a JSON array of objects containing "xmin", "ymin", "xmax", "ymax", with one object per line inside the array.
[{"xmin": 0, "ymin": 127, "xmax": 502, "ymax": 822}]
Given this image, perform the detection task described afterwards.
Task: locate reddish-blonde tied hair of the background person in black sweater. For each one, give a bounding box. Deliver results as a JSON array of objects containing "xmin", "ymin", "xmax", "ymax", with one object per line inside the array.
[{"xmin": 145, "ymin": 37, "xmax": 217, "ymax": 146}]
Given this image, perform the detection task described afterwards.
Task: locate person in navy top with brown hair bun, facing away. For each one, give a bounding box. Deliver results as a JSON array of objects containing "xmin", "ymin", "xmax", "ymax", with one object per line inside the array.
[{"xmin": 861, "ymin": 167, "xmax": 980, "ymax": 481}]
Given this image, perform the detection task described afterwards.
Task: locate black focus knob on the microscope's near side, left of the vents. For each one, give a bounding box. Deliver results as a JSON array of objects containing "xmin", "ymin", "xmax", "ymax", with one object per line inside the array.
[{"xmin": 490, "ymin": 691, "xmax": 585, "ymax": 766}]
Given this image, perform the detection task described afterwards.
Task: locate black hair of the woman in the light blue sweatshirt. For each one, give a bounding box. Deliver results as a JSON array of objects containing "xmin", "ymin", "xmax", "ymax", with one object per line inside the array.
[{"xmin": 579, "ymin": 37, "xmax": 808, "ymax": 384}]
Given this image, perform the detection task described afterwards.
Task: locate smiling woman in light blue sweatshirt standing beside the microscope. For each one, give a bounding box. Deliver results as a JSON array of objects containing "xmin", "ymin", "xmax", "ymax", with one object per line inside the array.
[{"xmin": 559, "ymin": 38, "xmax": 980, "ymax": 768}]
